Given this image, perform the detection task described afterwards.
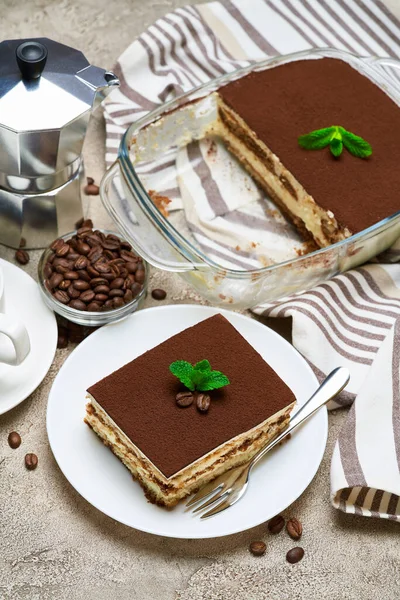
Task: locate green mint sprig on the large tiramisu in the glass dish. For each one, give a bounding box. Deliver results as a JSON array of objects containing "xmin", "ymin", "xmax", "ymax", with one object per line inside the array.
[{"xmin": 298, "ymin": 125, "xmax": 372, "ymax": 158}]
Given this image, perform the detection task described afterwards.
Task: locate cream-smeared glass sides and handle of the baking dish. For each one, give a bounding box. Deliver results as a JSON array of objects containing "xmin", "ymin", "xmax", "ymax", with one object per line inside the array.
[{"xmin": 100, "ymin": 48, "xmax": 400, "ymax": 308}]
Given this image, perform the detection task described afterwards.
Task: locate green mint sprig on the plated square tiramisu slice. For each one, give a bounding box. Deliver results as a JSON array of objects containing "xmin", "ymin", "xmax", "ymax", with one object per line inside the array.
[{"xmin": 169, "ymin": 360, "xmax": 230, "ymax": 392}]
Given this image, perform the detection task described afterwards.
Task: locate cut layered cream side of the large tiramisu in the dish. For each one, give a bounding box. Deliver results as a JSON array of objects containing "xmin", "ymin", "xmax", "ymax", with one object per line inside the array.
[{"xmin": 210, "ymin": 98, "xmax": 351, "ymax": 247}]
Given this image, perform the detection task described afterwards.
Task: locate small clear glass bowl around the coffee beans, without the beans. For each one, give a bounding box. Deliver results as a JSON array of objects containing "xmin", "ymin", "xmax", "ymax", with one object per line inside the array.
[{"xmin": 38, "ymin": 229, "xmax": 149, "ymax": 327}]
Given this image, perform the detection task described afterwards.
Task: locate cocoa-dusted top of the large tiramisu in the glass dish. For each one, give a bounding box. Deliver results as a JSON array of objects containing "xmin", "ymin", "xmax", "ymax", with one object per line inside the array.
[{"xmin": 219, "ymin": 58, "xmax": 400, "ymax": 233}]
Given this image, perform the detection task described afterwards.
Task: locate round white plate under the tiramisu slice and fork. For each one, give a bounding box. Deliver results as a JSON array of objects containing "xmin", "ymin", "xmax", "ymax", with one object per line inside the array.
[{"xmin": 47, "ymin": 305, "xmax": 328, "ymax": 538}]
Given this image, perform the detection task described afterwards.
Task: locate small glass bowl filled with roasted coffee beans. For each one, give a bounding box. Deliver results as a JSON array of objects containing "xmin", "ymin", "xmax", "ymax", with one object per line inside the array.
[{"xmin": 38, "ymin": 222, "xmax": 148, "ymax": 327}]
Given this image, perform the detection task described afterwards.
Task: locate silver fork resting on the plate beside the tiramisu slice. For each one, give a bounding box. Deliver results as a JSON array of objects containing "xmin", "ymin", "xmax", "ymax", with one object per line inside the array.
[{"xmin": 186, "ymin": 367, "xmax": 350, "ymax": 519}]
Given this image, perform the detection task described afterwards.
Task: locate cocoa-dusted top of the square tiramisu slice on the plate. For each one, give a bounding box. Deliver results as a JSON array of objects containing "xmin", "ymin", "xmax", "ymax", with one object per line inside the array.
[{"xmin": 88, "ymin": 315, "xmax": 295, "ymax": 477}]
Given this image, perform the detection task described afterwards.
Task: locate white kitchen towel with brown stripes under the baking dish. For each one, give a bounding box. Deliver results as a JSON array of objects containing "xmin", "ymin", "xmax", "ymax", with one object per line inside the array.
[{"xmin": 105, "ymin": 0, "xmax": 400, "ymax": 520}]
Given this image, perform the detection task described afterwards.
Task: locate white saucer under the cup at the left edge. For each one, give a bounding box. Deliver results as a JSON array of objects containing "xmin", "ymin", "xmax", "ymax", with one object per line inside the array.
[{"xmin": 0, "ymin": 259, "xmax": 57, "ymax": 415}]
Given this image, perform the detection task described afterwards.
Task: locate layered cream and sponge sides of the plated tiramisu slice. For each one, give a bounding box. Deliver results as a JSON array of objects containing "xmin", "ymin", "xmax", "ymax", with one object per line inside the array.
[{"xmin": 85, "ymin": 394, "xmax": 294, "ymax": 507}]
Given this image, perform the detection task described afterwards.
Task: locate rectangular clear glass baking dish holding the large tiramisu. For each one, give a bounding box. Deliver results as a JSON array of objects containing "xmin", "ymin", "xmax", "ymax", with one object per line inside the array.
[{"xmin": 100, "ymin": 48, "xmax": 400, "ymax": 308}]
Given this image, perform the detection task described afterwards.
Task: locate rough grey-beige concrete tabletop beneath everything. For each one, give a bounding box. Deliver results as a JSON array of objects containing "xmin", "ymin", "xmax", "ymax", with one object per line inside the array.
[{"xmin": 0, "ymin": 0, "xmax": 400, "ymax": 600}]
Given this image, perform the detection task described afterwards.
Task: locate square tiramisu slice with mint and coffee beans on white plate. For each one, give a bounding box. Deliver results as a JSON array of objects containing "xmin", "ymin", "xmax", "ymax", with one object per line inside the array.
[{"xmin": 85, "ymin": 315, "xmax": 295, "ymax": 507}]
